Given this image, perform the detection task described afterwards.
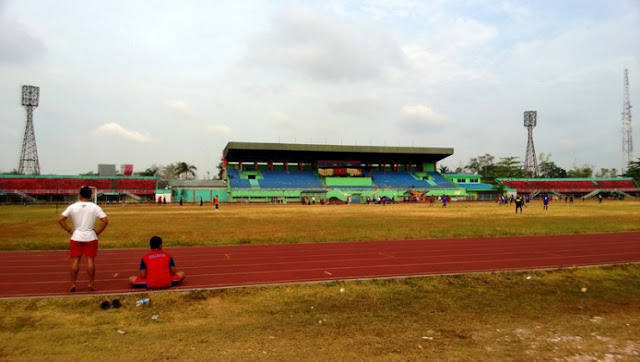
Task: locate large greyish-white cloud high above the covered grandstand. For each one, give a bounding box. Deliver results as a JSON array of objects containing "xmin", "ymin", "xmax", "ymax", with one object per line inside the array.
[{"xmin": 246, "ymin": 7, "xmax": 404, "ymax": 81}]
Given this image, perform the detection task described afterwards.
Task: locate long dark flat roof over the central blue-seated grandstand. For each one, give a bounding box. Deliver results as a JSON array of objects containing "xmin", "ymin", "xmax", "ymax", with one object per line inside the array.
[{"xmin": 222, "ymin": 142, "xmax": 453, "ymax": 163}]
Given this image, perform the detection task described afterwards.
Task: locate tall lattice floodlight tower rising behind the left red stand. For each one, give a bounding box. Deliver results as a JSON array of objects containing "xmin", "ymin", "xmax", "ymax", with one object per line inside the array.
[{"xmin": 18, "ymin": 85, "xmax": 40, "ymax": 175}]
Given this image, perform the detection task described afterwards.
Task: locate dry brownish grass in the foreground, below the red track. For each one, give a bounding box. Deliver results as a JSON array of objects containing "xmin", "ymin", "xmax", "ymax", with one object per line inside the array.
[{"xmin": 0, "ymin": 265, "xmax": 640, "ymax": 361}]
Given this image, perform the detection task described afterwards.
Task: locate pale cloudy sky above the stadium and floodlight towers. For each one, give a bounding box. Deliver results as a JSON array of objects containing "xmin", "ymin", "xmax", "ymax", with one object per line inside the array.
[{"xmin": 0, "ymin": 0, "xmax": 640, "ymax": 175}]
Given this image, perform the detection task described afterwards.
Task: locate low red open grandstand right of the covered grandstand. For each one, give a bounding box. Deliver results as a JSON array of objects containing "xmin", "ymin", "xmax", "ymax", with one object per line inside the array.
[{"xmin": 496, "ymin": 177, "xmax": 640, "ymax": 198}]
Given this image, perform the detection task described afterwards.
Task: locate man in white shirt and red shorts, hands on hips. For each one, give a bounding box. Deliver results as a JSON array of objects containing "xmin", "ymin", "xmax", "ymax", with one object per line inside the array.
[{"xmin": 58, "ymin": 186, "xmax": 109, "ymax": 292}]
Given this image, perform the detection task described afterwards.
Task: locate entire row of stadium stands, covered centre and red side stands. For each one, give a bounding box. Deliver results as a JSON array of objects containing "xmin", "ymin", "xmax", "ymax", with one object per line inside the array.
[{"xmin": 0, "ymin": 142, "xmax": 640, "ymax": 204}]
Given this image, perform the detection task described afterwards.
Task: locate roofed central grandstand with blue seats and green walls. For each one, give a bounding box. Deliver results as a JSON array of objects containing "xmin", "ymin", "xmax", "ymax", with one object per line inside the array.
[{"xmin": 223, "ymin": 142, "xmax": 466, "ymax": 203}]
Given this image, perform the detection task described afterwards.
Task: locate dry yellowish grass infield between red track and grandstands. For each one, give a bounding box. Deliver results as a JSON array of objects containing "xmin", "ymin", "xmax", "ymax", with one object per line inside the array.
[{"xmin": 0, "ymin": 200, "xmax": 640, "ymax": 250}]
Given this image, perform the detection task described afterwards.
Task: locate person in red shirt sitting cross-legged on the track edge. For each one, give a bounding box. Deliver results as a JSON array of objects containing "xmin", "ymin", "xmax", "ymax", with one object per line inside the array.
[{"xmin": 129, "ymin": 236, "xmax": 184, "ymax": 289}]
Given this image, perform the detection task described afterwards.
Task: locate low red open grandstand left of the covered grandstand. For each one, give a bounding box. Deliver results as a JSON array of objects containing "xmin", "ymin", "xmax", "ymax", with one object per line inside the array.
[{"xmin": 0, "ymin": 175, "xmax": 157, "ymax": 203}]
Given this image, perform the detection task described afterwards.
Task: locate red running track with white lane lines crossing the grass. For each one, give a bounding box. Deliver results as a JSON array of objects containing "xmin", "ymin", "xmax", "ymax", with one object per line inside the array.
[{"xmin": 0, "ymin": 232, "xmax": 640, "ymax": 298}]
